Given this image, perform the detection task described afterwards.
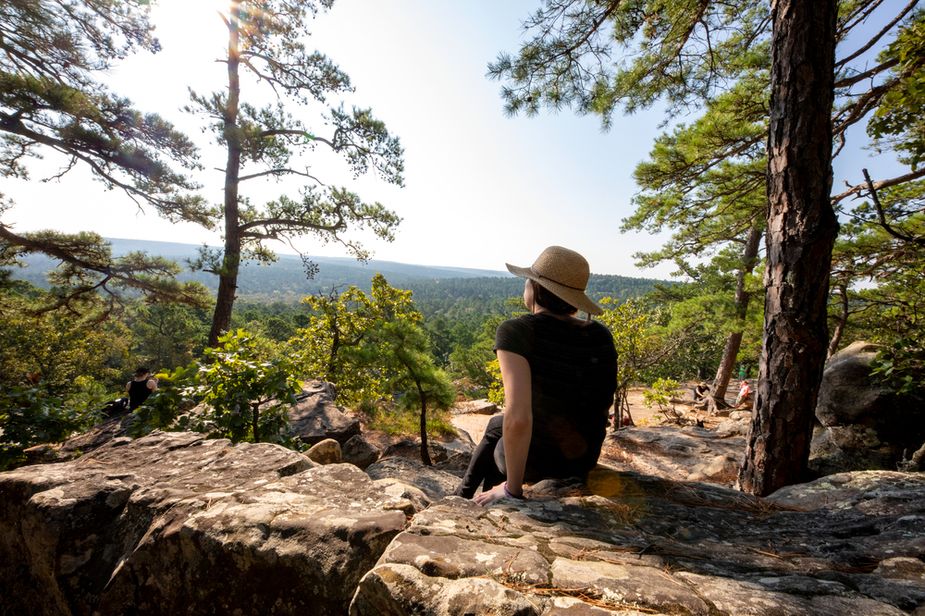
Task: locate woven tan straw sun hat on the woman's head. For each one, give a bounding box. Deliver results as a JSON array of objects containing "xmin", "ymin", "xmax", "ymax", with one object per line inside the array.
[{"xmin": 505, "ymin": 246, "xmax": 603, "ymax": 314}]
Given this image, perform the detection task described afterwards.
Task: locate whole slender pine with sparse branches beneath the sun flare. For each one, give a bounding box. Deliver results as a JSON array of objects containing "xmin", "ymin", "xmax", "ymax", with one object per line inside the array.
[{"xmin": 190, "ymin": 0, "xmax": 403, "ymax": 344}]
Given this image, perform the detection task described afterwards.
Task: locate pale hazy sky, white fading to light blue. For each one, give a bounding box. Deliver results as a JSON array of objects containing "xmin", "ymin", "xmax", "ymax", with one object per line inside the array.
[{"xmin": 2, "ymin": 0, "xmax": 895, "ymax": 278}]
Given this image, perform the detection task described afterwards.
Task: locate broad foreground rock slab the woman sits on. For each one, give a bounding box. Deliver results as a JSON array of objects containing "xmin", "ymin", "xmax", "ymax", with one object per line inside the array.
[{"xmin": 350, "ymin": 468, "xmax": 925, "ymax": 616}]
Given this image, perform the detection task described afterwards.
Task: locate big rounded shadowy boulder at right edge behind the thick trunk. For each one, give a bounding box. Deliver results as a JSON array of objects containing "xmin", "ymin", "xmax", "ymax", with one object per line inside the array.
[{"xmin": 809, "ymin": 342, "xmax": 925, "ymax": 475}]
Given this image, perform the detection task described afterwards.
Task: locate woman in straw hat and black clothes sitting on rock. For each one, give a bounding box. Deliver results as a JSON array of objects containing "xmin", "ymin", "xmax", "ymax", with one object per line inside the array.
[{"xmin": 456, "ymin": 246, "xmax": 617, "ymax": 505}]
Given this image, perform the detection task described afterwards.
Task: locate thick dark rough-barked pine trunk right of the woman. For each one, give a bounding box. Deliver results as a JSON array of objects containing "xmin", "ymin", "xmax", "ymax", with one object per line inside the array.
[{"xmin": 738, "ymin": 0, "xmax": 838, "ymax": 496}]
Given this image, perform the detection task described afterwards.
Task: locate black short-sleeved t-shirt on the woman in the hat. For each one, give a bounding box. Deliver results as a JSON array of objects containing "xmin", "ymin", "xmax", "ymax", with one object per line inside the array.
[{"xmin": 495, "ymin": 313, "xmax": 617, "ymax": 476}]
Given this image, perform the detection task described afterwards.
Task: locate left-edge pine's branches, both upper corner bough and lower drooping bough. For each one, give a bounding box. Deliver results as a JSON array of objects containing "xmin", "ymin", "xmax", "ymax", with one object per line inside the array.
[{"xmin": 0, "ymin": 0, "xmax": 213, "ymax": 309}]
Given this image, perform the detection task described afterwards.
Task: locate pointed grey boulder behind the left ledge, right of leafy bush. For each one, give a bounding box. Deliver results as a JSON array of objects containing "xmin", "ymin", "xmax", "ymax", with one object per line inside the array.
[{"xmin": 289, "ymin": 381, "xmax": 360, "ymax": 445}]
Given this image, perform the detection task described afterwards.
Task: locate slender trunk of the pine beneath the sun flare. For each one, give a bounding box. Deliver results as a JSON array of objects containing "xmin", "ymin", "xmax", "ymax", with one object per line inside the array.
[{"xmin": 209, "ymin": 0, "xmax": 241, "ymax": 346}]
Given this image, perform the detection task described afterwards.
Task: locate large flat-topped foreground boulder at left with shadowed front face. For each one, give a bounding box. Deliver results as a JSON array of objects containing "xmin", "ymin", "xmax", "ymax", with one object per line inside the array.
[{"xmin": 0, "ymin": 432, "xmax": 416, "ymax": 615}]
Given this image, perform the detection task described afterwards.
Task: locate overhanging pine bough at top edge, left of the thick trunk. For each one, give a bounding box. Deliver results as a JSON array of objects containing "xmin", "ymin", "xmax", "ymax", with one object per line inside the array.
[{"xmin": 488, "ymin": 0, "xmax": 770, "ymax": 126}]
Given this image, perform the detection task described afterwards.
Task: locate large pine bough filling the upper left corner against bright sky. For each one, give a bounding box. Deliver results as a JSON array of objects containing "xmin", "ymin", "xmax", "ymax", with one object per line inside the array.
[{"xmin": 0, "ymin": 0, "xmax": 209, "ymax": 213}]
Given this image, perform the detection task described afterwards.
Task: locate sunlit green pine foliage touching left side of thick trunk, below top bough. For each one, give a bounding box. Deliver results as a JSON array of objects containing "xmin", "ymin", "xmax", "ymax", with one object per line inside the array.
[{"xmin": 623, "ymin": 70, "xmax": 770, "ymax": 278}]
